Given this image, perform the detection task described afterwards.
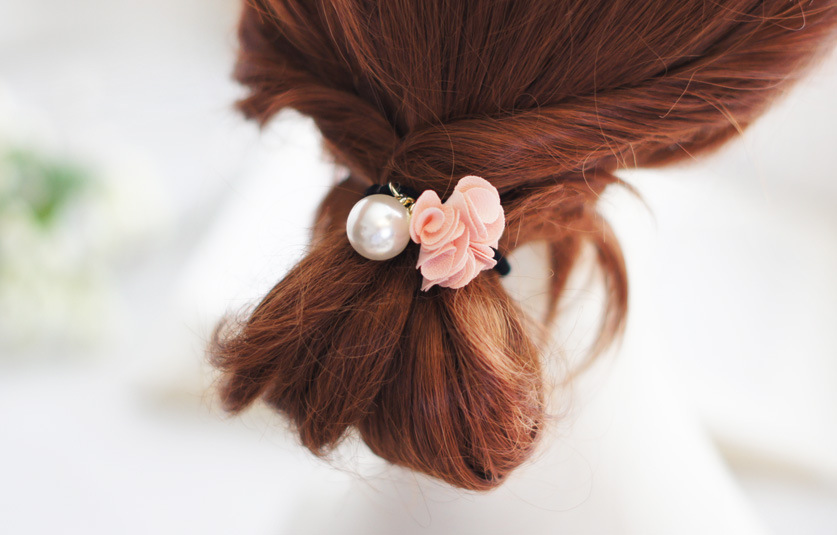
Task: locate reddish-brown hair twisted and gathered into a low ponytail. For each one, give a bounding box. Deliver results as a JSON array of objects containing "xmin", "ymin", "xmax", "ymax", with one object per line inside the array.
[{"xmin": 211, "ymin": 0, "xmax": 837, "ymax": 490}]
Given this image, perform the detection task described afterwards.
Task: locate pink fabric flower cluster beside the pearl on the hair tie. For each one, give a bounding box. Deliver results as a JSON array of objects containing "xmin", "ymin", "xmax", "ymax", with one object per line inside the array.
[{"xmin": 410, "ymin": 176, "xmax": 506, "ymax": 291}]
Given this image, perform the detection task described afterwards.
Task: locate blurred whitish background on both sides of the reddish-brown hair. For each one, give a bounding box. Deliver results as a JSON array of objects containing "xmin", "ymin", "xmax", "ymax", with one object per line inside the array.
[{"xmin": 0, "ymin": 0, "xmax": 837, "ymax": 534}]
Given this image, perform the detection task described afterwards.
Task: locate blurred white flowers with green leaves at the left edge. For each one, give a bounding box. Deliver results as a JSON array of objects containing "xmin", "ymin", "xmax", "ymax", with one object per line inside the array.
[{"xmin": 0, "ymin": 86, "xmax": 168, "ymax": 361}]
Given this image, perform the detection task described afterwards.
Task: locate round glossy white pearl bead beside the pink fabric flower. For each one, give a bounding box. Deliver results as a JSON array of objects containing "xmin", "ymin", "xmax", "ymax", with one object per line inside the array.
[{"xmin": 346, "ymin": 195, "xmax": 410, "ymax": 260}]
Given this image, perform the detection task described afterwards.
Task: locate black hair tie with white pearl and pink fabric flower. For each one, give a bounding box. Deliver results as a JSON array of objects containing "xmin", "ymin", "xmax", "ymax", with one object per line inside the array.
[{"xmin": 346, "ymin": 176, "xmax": 510, "ymax": 291}]
